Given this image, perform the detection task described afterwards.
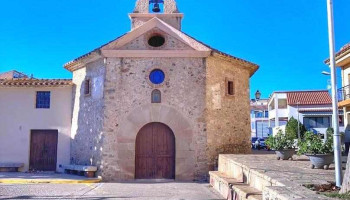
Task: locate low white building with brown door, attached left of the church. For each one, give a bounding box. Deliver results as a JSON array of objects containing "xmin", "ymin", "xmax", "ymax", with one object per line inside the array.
[{"xmin": 0, "ymin": 71, "xmax": 73, "ymax": 171}]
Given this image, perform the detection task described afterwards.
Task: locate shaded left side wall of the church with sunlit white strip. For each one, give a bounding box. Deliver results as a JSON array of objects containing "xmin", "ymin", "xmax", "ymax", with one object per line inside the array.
[{"xmin": 71, "ymin": 59, "xmax": 105, "ymax": 169}]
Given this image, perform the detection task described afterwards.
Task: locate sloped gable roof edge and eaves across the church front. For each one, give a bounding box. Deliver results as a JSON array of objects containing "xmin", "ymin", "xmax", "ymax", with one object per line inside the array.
[{"xmin": 64, "ymin": 17, "xmax": 259, "ymax": 74}]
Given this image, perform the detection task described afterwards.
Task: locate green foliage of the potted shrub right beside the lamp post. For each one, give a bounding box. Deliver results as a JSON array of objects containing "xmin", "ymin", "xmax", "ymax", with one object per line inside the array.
[{"xmin": 298, "ymin": 131, "xmax": 334, "ymax": 155}]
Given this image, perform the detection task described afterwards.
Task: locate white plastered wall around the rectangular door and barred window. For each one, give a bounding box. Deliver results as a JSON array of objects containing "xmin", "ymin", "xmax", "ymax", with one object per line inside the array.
[{"xmin": 0, "ymin": 86, "xmax": 72, "ymax": 171}]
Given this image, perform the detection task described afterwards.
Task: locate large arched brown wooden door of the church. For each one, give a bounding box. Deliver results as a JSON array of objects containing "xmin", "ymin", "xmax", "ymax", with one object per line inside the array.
[{"xmin": 135, "ymin": 123, "xmax": 175, "ymax": 179}]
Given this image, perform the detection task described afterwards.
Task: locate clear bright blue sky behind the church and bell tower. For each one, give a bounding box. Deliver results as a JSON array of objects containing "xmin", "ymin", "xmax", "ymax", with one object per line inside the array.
[{"xmin": 0, "ymin": 0, "xmax": 350, "ymax": 97}]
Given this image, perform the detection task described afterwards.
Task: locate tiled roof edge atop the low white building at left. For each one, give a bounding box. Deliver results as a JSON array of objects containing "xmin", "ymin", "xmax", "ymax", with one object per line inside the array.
[{"xmin": 0, "ymin": 78, "xmax": 73, "ymax": 87}]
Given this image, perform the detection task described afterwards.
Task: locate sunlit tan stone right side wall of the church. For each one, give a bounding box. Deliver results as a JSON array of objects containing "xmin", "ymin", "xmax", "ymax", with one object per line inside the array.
[{"xmin": 206, "ymin": 56, "xmax": 251, "ymax": 170}]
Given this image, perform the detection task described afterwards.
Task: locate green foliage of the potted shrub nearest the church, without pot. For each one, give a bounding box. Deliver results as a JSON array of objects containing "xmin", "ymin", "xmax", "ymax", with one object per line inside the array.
[{"xmin": 265, "ymin": 130, "xmax": 294, "ymax": 150}]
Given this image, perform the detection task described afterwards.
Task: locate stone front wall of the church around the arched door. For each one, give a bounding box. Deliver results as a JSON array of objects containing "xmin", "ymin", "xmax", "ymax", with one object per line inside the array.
[{"xmin": 101, "ymin": 58, "xmax": 208, "ymax": 180}]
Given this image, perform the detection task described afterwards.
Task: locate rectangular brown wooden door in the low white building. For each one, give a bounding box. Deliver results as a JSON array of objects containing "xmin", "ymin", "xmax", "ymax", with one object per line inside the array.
[{"xmin": 29, "ymin": 130, "xmax": 58, "ymax": 171}]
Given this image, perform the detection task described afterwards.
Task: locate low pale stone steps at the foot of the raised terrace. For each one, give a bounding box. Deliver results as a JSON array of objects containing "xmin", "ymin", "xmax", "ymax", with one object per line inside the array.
[{"xmin": 209, "ymin": 171, "xmax": 262, "ymax": 200}]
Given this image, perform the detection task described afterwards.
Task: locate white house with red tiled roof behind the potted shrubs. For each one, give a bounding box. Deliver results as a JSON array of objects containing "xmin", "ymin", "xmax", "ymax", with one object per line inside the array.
[{"xmin": 268, "ymin": 90, "xmax": 344, "ymax": 134}]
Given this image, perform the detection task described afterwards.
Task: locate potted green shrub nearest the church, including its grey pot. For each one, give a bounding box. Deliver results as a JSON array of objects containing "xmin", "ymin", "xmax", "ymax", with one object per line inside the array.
[{"xmin": 266, "ymin": 130, "xmax": 295, "ymax": 160}]
